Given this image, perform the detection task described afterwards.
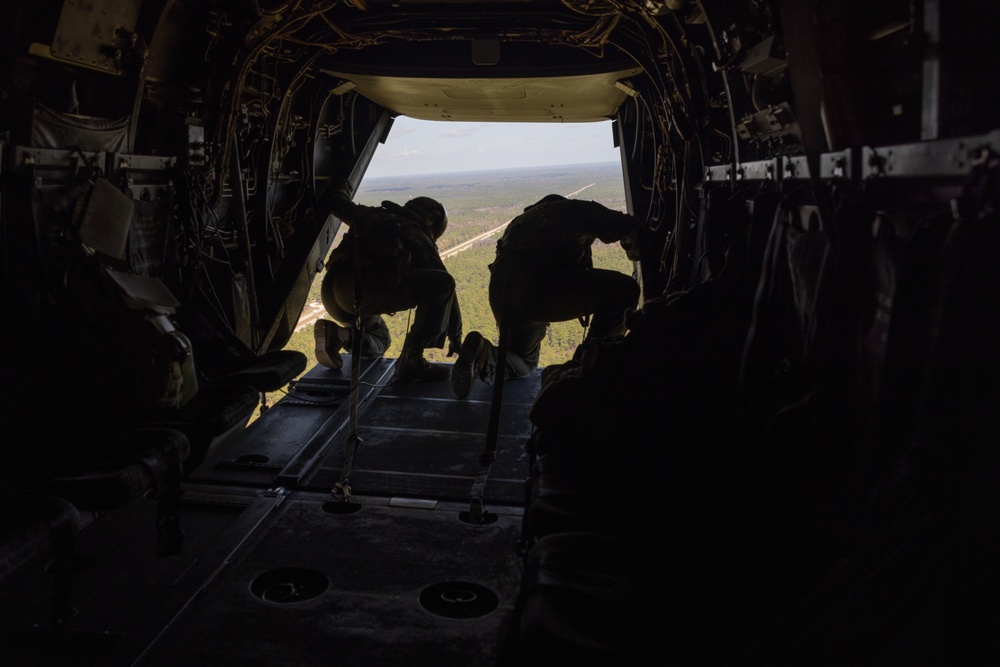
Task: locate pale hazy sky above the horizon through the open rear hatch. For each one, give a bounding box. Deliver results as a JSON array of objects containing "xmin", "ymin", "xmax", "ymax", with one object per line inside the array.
[{"xmin": 365, "ymin": 116, "xmax": 621, "ymax": 178}]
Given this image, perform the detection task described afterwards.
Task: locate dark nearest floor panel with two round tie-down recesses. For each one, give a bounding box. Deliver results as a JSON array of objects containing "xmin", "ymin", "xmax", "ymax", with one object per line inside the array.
[{"xmin": 133, "ymin": 500, "xmax": 520, "ymax": 666}]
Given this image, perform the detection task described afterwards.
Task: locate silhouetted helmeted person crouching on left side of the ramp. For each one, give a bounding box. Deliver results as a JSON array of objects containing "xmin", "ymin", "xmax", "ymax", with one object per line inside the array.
[{"xmin": 314, "ymin": 190, "xmax": 462, "ymax": 382}]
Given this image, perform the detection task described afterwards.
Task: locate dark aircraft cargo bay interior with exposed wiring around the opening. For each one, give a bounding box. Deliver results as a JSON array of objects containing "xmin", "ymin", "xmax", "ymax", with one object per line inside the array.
[{"xmin": 0, "ymin": 0, "xmax": 1000, "ymax": 667}]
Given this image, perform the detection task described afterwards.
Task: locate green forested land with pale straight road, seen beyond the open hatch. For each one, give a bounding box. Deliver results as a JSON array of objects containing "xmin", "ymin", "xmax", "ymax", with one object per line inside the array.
[{"xmin": 278, "ymin": 162, "xmax": 633, "ymax": 396}]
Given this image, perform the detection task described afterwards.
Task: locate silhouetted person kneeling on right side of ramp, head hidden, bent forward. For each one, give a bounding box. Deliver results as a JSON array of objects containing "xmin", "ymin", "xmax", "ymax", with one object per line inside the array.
[{"xmin": 451, "ymin": 195, "xmax": 639, "ymax": 398}]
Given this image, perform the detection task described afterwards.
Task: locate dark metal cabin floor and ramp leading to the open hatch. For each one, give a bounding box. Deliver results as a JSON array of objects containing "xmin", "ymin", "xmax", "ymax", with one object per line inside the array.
[{"xmin": 2, "ymin": 359, "xmax": 540, "ymax": 665}]
